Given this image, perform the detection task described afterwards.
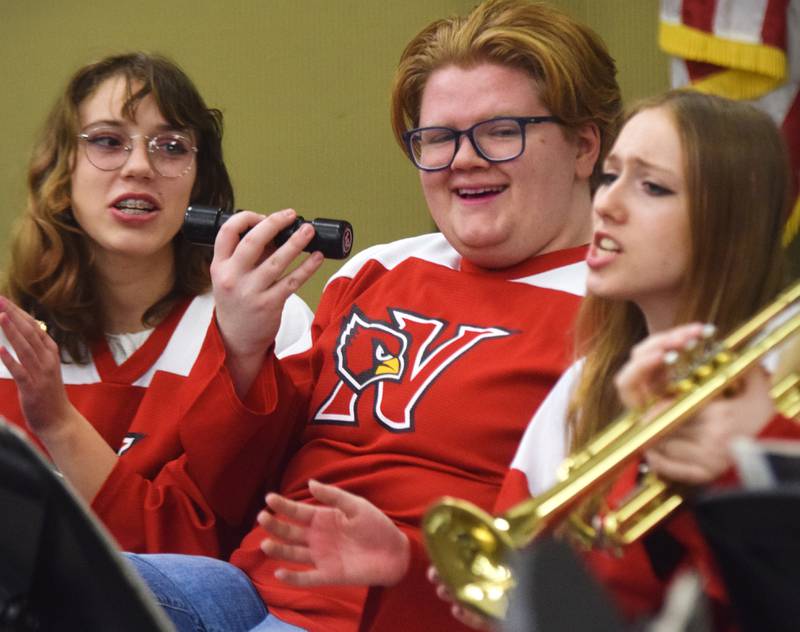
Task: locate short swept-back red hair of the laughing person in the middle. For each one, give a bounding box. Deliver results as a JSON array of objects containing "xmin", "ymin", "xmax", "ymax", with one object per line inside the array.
[{"xmin": 391, "ymin": 0, "xmax": 622, "ymax": 190}]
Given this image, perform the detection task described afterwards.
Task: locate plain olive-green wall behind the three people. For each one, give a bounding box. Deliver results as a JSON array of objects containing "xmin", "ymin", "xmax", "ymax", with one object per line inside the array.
[{"xmin": 0, "ymin": 0, "xmax": 667, "ymax": 306}]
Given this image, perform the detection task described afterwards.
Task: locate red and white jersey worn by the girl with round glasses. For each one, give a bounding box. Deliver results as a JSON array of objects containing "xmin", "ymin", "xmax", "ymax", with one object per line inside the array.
[{"xmin": 0, "ymin": 294, "xmax": 313, "ymax": 556}]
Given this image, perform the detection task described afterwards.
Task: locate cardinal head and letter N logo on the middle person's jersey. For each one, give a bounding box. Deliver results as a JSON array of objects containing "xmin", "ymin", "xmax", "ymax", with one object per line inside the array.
[{"xmin": 314, "ymin": 306, "xmax": 512, "ymax": 432}]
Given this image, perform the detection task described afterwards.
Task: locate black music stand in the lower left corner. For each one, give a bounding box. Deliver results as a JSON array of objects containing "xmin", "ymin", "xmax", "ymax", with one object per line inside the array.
[{"xmin": 0, "ymin": 418, "xmax": 174, "ymax": 632}]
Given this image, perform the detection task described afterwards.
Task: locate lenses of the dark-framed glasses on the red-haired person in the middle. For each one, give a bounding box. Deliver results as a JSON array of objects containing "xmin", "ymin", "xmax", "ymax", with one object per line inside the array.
[{"xmin": 410, "ymin": 119, "xmax": 524, "ymax": 169}]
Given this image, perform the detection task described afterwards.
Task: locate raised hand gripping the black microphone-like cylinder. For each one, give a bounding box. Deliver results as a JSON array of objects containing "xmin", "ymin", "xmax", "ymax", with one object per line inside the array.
[{"xmin": 211, "ymin": 210, "xmax": 323, "ymax": 397}]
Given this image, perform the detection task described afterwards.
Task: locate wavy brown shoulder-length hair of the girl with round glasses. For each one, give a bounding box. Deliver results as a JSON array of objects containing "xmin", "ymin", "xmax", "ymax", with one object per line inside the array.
[{"xmin": 3, "ymin": 52, "xmax": 234, "ymax": 362}]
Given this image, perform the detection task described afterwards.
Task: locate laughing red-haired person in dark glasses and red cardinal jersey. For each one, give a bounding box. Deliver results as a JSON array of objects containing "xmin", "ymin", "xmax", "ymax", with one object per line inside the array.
[{"xmin": 109, "ymin": 0, "xmax": 621, "ymax": 630}]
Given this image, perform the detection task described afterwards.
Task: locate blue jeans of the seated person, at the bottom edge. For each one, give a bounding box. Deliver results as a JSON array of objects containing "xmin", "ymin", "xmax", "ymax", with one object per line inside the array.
[{"xmin": 125, "ymin": 553, "xmax": 302, "ymax": 632}]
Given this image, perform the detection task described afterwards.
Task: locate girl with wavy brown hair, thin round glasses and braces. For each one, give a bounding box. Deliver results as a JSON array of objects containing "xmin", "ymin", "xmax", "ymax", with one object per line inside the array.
[{"xmin": 0, "ymin": 53, "xmax": 311, "ymax": 556}]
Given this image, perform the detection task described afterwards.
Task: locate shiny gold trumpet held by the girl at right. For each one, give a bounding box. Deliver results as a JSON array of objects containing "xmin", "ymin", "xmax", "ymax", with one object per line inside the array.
[{"xmin": 422, "ymin": 282, "xmax": 800, "ymax": 619}]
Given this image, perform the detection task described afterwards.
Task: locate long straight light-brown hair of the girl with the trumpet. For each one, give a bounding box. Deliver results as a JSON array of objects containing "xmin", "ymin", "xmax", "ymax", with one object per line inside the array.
[{"xmin": 568, "ymin": 91, "xmax": 791, "ymax": 448}]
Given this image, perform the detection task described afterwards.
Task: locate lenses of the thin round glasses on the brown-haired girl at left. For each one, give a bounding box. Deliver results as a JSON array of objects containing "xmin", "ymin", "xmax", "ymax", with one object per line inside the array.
[{"xmin": 79, "ymin": 129, "xmax": 197, "ymax": 178}]
